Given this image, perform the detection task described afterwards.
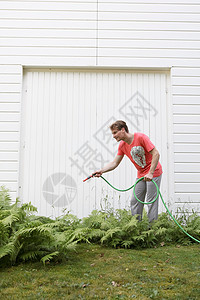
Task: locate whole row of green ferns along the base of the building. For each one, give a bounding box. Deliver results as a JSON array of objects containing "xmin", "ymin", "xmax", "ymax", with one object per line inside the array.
[{"xmin": 0, "ymin": 187, "xmax": 200, "ymax": 264}]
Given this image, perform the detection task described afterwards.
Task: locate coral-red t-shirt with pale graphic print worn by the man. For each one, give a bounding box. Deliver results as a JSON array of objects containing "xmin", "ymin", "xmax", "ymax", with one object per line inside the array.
[{"xmin": 117, "ymin": 132, "xmax": 162, "ymax": 178}]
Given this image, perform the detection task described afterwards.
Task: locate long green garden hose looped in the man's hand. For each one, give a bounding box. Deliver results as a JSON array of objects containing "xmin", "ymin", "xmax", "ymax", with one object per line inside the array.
[{"xmin": 100, "ymin": 176, "xmax": 200, "ymax": 243}]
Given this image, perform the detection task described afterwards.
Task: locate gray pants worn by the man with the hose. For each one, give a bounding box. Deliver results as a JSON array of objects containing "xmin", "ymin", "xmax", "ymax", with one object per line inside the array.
[{"xmin": 131, "ymin": 175, "xmax": 162, "ymax": 222}]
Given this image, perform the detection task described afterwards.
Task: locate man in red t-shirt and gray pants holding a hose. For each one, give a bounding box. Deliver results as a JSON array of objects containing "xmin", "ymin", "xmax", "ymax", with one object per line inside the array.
[{"xmin": 93, "ymin": 120, "xmax": 162, "ymax": 223}]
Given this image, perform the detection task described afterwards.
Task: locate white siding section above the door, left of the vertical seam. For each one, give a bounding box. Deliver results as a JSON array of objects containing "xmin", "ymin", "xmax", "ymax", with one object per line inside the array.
[{"xmin": 0, "ymin": 0, "xmax": 97, "ymax": 66}]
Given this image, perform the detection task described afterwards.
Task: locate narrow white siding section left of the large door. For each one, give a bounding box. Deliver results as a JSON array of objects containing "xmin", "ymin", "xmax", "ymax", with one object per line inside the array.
[{"xmin": 0, "ymin": 65, "xmax": 22, "ymax": 198}]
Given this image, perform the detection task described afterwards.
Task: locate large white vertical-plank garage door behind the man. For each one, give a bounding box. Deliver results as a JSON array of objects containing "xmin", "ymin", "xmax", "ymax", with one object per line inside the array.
[{"xmin": 20, "ymin": 69, "xmax": 170, "ymax": 217}]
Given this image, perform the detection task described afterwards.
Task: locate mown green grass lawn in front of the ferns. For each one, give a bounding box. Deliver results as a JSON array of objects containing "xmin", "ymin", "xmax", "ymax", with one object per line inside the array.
[{"xmin": 0, "ymin": 244, "xmax": 200, "ymax": 300}]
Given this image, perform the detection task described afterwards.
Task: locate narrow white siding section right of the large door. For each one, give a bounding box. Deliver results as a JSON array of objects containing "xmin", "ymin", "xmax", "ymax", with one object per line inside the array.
[{"xmin": 172, "ymin": 67, "xmax": 200, "ymax": 212}]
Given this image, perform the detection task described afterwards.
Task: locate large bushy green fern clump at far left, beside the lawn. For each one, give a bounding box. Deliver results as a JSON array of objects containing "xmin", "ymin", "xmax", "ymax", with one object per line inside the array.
[{"xmin": 0, "ymin": 188, "xmax": 78, "ymax": 264}]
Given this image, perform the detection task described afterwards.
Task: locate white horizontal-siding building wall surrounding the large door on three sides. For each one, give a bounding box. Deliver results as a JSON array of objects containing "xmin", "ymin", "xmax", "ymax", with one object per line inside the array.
[{"xmin": 0, "ymin": 0, "xmax": 200, "ymax": 211}]
